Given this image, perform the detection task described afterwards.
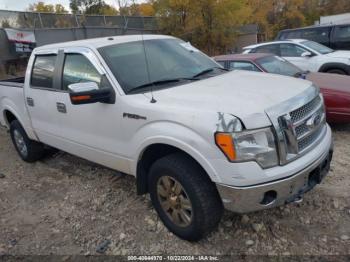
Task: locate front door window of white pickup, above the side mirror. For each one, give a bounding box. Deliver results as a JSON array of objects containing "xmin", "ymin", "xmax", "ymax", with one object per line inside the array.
[{"xmin": 62, "ymin": 54, "xmax": 101, "ymax": 90}]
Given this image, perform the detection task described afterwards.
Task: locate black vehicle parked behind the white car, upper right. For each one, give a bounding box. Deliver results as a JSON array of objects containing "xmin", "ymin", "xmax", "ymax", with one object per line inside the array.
[{"xmin": 276, "ymin": 24, "xmax": 350, "ymax": 50}]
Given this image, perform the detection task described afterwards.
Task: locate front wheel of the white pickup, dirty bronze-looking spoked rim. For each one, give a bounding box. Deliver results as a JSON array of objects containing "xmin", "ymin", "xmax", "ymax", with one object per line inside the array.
[{"xmin": 148, "ymin": 153, "xmax": 224, "ymax": 241}]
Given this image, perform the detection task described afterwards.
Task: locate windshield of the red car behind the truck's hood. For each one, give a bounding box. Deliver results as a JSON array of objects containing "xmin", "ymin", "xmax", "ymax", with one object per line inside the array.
[{"xmin": 256, "ymin": 56, "xmax": 302, "ymax": 76}]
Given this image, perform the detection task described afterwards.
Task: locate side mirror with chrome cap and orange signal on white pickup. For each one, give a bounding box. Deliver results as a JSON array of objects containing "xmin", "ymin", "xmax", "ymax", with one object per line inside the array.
[{"xmin": 68, "ymin": 82, "xmax": 115, "ymax": 105}]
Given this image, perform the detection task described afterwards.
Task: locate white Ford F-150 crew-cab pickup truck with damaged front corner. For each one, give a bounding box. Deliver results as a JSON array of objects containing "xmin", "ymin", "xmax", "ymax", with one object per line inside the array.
[{"xmin": 0, "ymin": 35, "xmax": 333, "ymax": 241}]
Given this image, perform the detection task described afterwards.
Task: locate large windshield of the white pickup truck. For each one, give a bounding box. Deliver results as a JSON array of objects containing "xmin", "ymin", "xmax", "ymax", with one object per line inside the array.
[{"xmin": 99, "ymin": 39, "xmax": 224, "ymax": 93}]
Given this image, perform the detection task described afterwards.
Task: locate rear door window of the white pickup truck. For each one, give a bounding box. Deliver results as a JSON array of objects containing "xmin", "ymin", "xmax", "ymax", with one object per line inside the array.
[{"xmin": 30, "ymin": 55, "xmax": 57, "ymax": 89}]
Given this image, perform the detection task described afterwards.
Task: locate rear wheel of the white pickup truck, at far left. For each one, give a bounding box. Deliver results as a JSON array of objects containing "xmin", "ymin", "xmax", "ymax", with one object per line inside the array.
[{"xmin": 10, "ymin": 120, "xmax": 45, "ymax": 163}]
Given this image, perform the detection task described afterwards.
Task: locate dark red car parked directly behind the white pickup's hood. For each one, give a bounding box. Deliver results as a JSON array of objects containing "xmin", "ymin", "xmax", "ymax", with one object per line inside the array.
[{"xmin": 214, "ymin": 53, "xmax": 350, "ymax": 124}]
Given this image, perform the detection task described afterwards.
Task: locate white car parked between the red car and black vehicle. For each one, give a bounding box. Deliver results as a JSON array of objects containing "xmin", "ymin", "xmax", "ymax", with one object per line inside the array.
[{"xmin": 243, "ymin": 39, "xmax": 350, "ymax": 75}]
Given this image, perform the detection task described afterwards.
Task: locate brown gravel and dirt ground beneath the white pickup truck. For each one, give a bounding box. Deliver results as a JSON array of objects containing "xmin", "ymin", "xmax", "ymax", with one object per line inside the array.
[{"xmin": 0, "ymin": 126, "xmax": 350, "ymax": 255}]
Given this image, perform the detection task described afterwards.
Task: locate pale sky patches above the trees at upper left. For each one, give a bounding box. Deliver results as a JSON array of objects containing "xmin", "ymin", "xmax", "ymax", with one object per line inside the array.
[{"xmin": 0, "ymin": 0, "xmax": 136, "ymax": 11}]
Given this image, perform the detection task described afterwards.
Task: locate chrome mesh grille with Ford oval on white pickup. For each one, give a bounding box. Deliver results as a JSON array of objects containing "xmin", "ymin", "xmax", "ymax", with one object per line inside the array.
[{"xmin": 279, "ymin": 95, "xmax": 326, "ymax": 163}]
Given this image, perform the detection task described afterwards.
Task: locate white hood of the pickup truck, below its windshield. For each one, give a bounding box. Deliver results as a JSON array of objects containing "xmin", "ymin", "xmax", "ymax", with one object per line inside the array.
[{"xmin": 154, "ymin": 70, "xmax": 312, "ymax": 128}]
